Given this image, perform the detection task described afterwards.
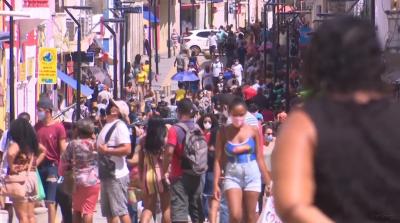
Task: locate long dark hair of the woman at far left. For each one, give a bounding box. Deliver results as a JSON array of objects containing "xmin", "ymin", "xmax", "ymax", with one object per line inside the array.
[{"xmin": 8, "ymin": 118, "xmax": 39, "ymax": 155}]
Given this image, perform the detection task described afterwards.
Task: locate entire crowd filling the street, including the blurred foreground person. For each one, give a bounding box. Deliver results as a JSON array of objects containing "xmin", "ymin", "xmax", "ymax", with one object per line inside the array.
[{"xmin": 0, "ymin": 15, "xmax": 400, "ymax": 223}]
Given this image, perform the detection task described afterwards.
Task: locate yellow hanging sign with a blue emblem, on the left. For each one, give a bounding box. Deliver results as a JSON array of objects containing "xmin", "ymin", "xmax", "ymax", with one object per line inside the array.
[{"xmin": 38, "ymin": 47, "xmax": 57, "ymax": 84}]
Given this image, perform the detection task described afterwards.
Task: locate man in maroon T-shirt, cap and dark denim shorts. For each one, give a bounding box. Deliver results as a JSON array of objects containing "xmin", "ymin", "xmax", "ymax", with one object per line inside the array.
[{"xmin": 35, "ymin": 96, "xmax": 72, "ymax": 223}]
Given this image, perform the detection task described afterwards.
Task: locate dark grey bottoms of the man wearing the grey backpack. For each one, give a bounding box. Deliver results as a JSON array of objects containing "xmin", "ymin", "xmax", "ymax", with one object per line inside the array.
[{"xmin": 171, "ymin": 174, "xmax": 204, "ymax": 222}]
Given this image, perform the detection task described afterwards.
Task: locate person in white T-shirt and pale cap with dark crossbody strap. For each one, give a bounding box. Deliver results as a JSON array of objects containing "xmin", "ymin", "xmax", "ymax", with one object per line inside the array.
[{"xmin": 97, "ymin": 100, "xmax": 131, "ymax": 223}]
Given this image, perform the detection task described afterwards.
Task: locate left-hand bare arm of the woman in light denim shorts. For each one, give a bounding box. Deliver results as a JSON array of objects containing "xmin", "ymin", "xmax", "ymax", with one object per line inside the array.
[{"xmin": 214, "ymin": 127, "xmax": 225, "ymax": 200}]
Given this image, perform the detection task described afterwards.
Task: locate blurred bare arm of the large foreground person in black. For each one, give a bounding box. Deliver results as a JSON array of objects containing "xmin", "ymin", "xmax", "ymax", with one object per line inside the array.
[{"xmin": 272, "ymin": 111, "xmax": 333, "ymax": 223}]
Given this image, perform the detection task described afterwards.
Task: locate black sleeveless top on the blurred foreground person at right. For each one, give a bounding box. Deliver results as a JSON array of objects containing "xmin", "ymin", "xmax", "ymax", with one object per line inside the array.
[{"xmin": 304, "ymin": 98, "xmax": 400, "ymax": 223}]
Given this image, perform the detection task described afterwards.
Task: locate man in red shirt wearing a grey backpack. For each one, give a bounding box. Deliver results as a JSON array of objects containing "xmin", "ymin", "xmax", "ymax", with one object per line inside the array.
[{"xmin": 163, "ymin": 99, "xmax": 208, "ymax": 223}]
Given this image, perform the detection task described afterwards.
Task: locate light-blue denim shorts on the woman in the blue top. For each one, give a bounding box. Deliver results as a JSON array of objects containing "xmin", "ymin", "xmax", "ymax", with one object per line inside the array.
[{"xmin": 224, "ymin": 160, "xmax": 261, "ymax": 192}]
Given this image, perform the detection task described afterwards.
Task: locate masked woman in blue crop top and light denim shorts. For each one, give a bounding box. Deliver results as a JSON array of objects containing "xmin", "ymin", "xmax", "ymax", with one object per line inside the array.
[{"xmin": 214, "ymin": 98, "xmax": 269, "ymax": 223}]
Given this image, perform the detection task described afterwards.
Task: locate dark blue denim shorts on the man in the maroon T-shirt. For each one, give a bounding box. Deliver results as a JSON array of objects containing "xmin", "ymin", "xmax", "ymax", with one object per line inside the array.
[{"xmin": 39, "ymin": 162, "xmax": 58, "ymax": 202}]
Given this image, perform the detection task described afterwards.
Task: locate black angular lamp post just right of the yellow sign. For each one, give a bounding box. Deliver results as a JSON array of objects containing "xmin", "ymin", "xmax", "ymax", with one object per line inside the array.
[{"xmin": 64, "ymin": 6, "xmax": 92, "ymax": 121}]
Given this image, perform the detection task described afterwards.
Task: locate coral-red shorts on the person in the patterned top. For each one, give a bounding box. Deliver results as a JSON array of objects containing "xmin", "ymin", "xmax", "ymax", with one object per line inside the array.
[{"xmin": 72, "ymin": 184, "xmax": 100, "ymax": 214}]
